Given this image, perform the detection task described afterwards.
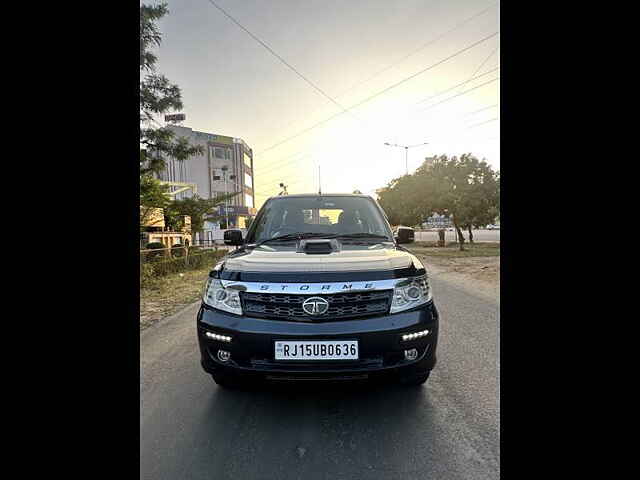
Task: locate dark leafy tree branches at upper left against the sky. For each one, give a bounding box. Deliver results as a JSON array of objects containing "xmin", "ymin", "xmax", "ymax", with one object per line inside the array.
[{"xmin": 140, "ymin": 3, "xmax": 204, "ymax": 176}]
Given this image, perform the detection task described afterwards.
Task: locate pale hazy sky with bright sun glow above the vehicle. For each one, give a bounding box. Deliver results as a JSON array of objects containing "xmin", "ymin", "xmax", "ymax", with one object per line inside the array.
[{"xmin": 150, "ymin": 0, "xmax": 500, "ymax": 208}]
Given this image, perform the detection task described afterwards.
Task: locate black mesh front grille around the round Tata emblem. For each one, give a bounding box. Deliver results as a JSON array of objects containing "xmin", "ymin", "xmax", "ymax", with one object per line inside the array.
[{"xmin": 240, "ymin": 290, "xmax": 393, "ymax": 322}]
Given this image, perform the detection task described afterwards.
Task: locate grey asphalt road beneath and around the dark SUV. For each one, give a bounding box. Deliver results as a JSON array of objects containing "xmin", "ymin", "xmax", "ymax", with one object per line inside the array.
[{"xmin": 140, "ymin": 275, "xmax": 500, "ymax": 480}]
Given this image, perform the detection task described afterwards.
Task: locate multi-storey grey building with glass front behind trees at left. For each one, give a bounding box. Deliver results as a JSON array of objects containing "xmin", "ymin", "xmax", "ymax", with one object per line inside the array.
[{"xmin": 158, "ymin": 125, "xmax": 256, "ymax": 240}]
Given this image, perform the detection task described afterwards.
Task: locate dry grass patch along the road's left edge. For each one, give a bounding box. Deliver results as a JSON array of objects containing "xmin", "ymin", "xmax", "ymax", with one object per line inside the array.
[{"xmin": 140, "ymin": 265, "xmax": 213, "ymax": 329}]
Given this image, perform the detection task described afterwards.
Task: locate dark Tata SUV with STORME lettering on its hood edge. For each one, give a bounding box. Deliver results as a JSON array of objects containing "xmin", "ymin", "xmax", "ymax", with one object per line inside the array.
[{"xmin": 197, "ymin": 194, "xmax": 438, "ymax": 387}]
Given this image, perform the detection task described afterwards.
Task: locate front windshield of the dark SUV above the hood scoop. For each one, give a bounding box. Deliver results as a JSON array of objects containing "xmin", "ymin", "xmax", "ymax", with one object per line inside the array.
[{"xmin": 247, "ymin": 196, "xmax": 393, "ymax": 243}]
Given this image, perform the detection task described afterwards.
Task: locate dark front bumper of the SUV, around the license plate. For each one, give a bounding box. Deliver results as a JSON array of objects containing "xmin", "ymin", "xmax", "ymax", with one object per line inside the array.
[{"xmin": 197, "ymin": 302, "xmax": 439, "ymax": 380}]
